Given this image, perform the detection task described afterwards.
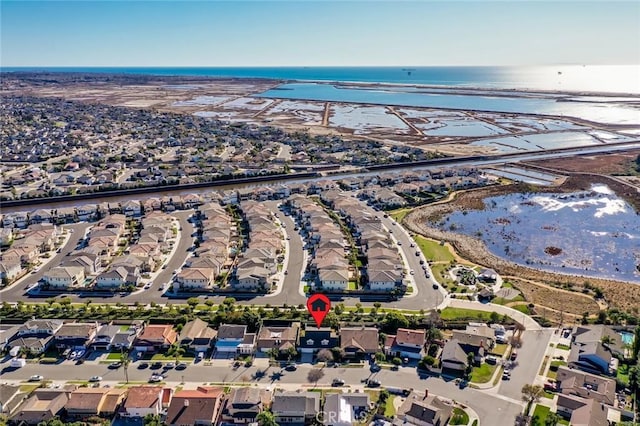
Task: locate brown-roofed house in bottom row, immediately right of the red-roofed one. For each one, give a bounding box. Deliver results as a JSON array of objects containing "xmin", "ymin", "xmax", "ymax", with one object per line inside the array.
[{"xmin": 164, "ymin": 386, "xmax": 224, "ymax": 426}]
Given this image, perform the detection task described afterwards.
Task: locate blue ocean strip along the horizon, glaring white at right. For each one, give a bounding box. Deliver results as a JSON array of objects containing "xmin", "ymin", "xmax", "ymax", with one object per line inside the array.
[{"xmin": 0, "ymin": 65, "xmax": 640, "ymax": 94}]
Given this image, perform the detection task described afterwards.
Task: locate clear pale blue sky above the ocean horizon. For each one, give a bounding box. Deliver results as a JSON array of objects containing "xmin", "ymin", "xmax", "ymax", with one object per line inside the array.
[{"xmin": 0, "ymin": 0, "xmax": 640, "ymax": 67}]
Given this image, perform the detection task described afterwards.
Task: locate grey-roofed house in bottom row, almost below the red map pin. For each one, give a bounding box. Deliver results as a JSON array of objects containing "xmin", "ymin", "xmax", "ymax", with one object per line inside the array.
[{"xmin": 271, "ymin": 392, "xmax": 320, "ymax": 426}]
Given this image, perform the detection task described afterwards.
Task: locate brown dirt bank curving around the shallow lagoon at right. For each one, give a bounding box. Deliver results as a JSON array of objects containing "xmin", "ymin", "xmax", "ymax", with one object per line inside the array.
[{"xmin": 403, "ymin": 174, "xmax": 640, "ymax": 313}]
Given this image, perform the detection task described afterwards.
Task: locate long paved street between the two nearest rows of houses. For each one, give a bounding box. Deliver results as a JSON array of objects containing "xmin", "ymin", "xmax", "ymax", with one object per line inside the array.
[{"xmin": 2, "ymin": 361, "xmax": 522, "ymax": 426}]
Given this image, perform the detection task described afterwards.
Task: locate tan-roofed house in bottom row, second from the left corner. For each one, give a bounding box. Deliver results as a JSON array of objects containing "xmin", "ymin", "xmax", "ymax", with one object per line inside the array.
[{"xmin": 9, "ymin": 386, "xmax": 75, "ymax": 425}]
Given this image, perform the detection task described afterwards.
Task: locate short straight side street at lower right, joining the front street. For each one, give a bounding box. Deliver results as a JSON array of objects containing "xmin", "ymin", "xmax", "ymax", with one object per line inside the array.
[{"xmin": 498, "ymin": 329, "xmax": 553, "ymax": 398}]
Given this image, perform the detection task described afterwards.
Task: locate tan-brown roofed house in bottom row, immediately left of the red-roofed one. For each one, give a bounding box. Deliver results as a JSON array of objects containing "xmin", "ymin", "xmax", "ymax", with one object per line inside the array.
[{"xmin": 64, "ymin": 387, "xmax": 127, "ymax": 418}]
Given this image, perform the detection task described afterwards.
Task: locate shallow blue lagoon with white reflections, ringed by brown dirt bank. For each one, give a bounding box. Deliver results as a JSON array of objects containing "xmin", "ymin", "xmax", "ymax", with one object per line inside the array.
[{"xmin": 435, "ymin": 185, "xmax": 640, "ymax": 283}]
